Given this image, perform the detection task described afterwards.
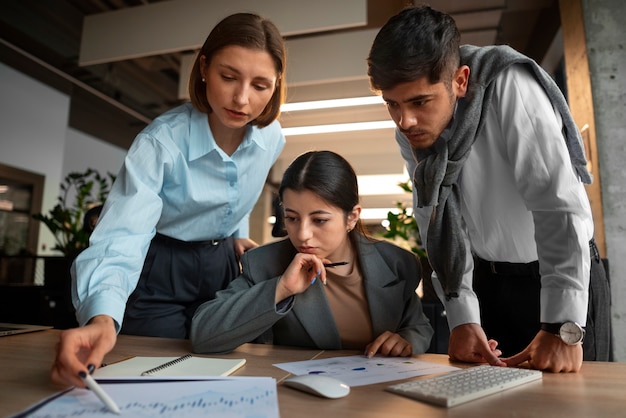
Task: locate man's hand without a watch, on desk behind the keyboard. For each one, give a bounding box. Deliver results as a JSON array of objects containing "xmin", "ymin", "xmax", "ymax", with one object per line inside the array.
[{"xmin": 448, "ymin": 324, "xmax": 506, "ymax": 366}]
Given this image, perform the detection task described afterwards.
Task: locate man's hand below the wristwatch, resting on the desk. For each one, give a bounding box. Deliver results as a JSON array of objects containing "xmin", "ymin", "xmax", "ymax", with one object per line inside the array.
[{"xmin": 503, "ymin": 331, "xmax": 583, "ymax": 373}]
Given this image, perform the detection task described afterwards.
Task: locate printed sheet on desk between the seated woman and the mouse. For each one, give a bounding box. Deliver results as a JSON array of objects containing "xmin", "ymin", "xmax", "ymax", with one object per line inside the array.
[{"xmin": 274, "ymin": 356, "xmax": 459, "ymax": 386}]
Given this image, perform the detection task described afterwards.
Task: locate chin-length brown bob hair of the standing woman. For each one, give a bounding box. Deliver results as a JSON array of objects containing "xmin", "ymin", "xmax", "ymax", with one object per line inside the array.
[{"xmin": 189, "ymin": 13, "xmax": 287, "ymax": 128}]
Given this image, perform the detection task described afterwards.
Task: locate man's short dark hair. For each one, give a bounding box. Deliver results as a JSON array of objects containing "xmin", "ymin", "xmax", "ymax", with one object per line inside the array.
[{"xmin": 367, "ymin": 6, "xmax": 461, "ymax": 91}]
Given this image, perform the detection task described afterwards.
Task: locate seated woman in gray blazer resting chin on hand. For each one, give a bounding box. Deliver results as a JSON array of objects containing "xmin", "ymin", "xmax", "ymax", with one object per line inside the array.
[{"xmin": 191, "ymin": 151, "xmax": 433, "ymax": 357}]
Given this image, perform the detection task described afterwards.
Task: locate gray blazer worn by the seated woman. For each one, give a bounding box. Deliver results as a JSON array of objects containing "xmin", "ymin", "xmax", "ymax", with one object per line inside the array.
[{"xmin": 191, "ymin": 237, "xmax": 433, "ymax": 354}]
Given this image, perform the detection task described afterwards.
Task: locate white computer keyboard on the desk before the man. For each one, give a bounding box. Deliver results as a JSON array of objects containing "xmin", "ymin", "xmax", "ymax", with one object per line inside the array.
[{"xmin": 386, "ymin": 365, "xmax": 542, "ymax": 407}]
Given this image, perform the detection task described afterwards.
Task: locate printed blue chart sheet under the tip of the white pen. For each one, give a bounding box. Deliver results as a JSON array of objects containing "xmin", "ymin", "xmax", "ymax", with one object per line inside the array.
[{"xmin": 13, "ymin": 377, "xmax": 279, "ymax": 418}]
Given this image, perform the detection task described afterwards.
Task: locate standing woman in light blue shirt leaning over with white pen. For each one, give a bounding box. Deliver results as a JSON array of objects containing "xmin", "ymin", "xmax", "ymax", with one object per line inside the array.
[{"xmin": 51, "ymin": 13, "xmax": 286, "ymax": 387}]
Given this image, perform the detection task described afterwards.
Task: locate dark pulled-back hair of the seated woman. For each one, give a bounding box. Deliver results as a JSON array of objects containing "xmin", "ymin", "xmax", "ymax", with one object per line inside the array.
[{"xmin": 278, "ymin": 151, "xmax": 366, "ymax": 244}]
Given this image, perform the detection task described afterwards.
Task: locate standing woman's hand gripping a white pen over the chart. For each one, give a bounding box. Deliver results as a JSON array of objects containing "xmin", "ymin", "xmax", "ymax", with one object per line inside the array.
[{"xmin": 50, "ymin": 315, "xmax": 117, "ymax": 387}]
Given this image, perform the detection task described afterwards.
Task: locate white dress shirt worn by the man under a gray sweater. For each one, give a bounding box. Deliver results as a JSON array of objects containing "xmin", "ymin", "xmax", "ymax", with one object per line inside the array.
[{"xmin": 396, "ymin": 65, "xmax": 593, "ymax": 329}]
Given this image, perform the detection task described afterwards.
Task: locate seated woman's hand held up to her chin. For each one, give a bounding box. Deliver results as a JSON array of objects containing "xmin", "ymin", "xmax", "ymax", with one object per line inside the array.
[{"xmin": 276, "ymin": 253, "xmax": 327, "ymax": 303}]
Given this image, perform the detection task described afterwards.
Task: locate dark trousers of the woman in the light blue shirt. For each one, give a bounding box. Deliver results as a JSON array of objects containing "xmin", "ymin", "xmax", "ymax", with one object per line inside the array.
[{"xmin": 121, "ymin": 234, "xmax": 240, "ymax": 338}]
